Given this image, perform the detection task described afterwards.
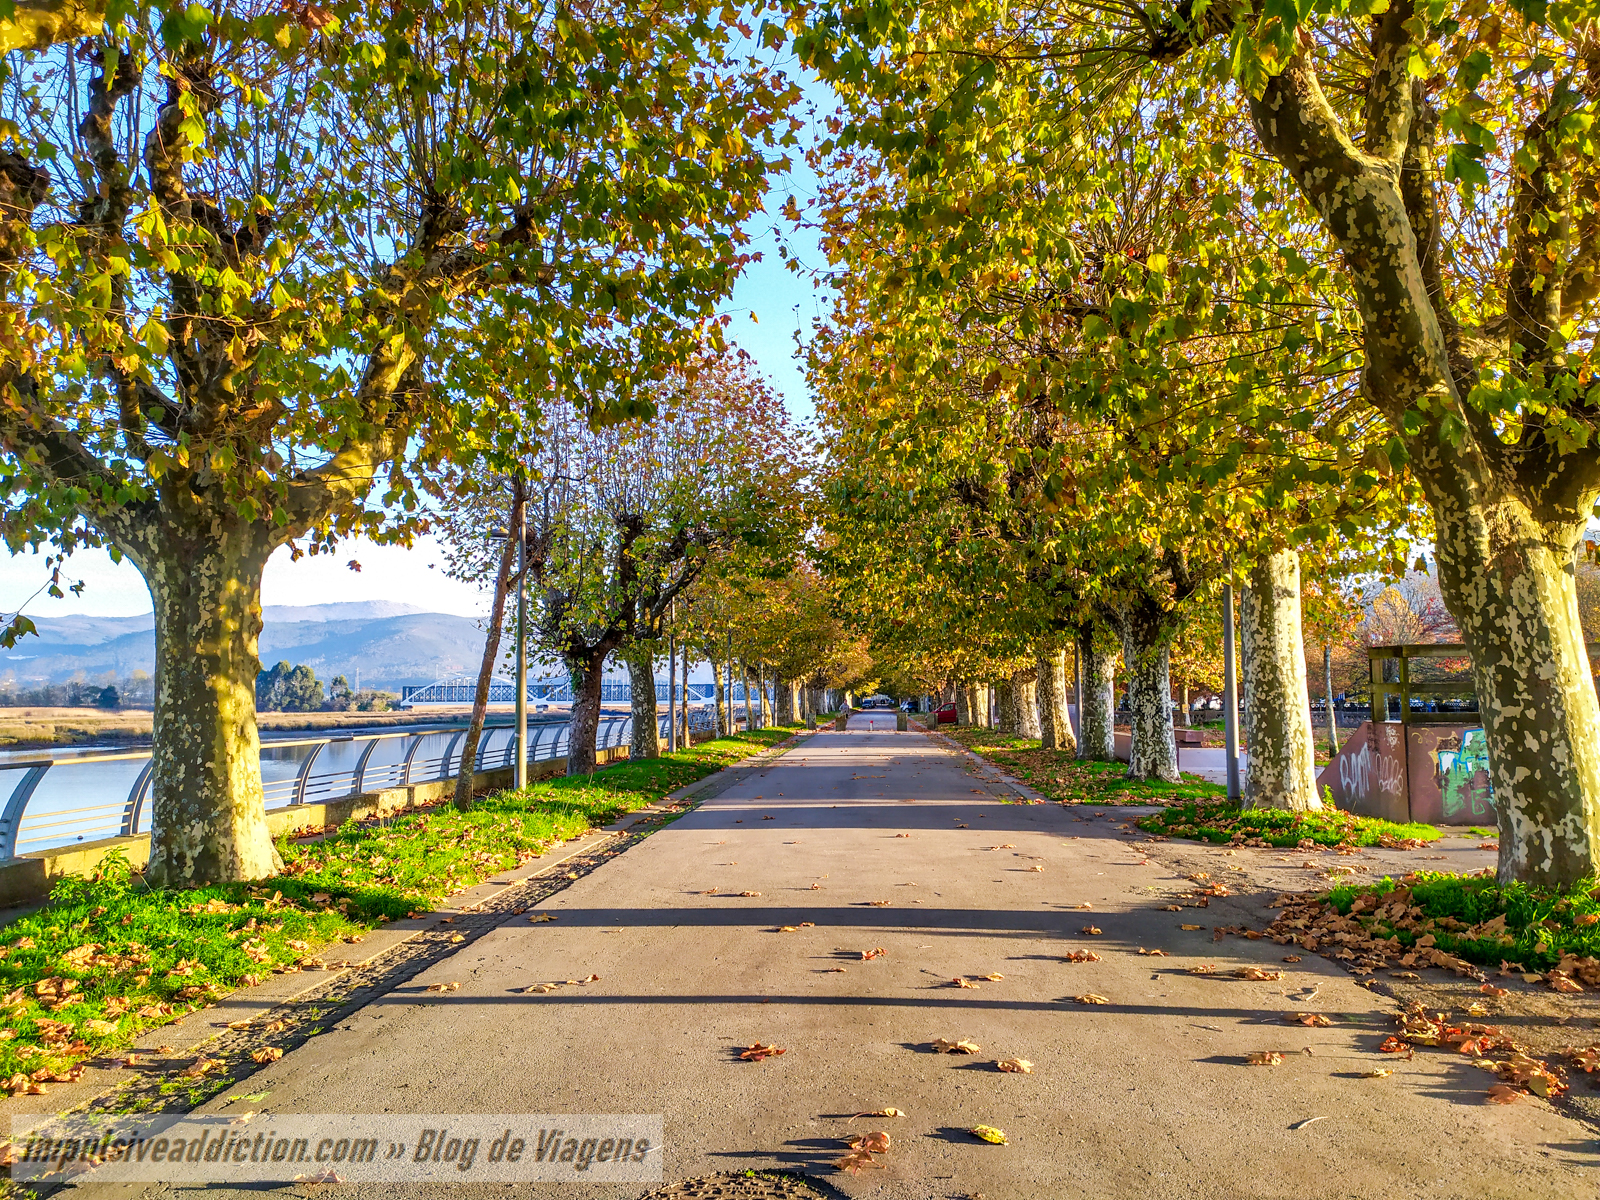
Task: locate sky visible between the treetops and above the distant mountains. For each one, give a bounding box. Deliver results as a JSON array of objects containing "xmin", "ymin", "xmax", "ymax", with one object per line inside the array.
[{"xmin": 0, "ymin": 66, "xmax": 827, "ymax": 618}]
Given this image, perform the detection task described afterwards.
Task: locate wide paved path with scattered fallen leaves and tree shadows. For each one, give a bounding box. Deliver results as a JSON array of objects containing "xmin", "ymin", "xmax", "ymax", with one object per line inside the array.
[{"xmin": 116, "ymin": 714, "xmax": 1600, "ymax": 1200}]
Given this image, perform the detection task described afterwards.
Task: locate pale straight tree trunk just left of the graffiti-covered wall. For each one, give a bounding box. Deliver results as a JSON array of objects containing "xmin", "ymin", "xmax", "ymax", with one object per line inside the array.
[{"xmin": 1238, "ymin": 550, "xmax": 1322, "ymax": 813}]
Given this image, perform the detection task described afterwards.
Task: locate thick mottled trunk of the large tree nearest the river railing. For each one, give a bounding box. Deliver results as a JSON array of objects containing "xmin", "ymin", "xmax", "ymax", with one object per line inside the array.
[{"xmin": 140, "ymin": 525, "xmax": 283, "ymax": 888}]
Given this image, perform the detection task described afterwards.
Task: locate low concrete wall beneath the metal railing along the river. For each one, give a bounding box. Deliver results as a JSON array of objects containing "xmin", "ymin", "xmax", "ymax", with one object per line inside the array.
[{"xmin": 0, "ymin": 746, "xmax": 627, "ymax": 909}]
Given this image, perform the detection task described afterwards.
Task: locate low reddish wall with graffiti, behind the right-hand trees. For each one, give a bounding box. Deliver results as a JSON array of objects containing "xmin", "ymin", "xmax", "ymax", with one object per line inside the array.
[{"xmin": 1317, "ymin": 722, "xmax": 1494, "ymax": 826}]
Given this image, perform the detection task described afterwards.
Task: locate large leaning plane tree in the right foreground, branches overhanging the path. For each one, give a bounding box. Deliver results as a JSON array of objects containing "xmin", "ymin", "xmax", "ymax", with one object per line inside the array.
[{"xmin": 792, "ymin": 0, "xmax": 1600, "ymax": 885}]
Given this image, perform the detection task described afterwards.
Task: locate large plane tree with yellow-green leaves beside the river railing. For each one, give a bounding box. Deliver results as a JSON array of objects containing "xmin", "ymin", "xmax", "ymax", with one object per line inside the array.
[{"xmin": 0, "ymin": 2, "xmax": 790, "ymax": 885}]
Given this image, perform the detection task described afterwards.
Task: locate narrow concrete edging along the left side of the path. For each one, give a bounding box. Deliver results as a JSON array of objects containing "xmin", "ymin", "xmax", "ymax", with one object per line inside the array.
[{"xmin": 0, "ymin": 730, "xmax": 810, "ymax": 1138}]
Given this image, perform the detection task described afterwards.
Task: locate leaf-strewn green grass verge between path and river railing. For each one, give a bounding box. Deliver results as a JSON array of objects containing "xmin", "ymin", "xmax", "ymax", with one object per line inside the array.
[{"xmin": 0, "ymin": 730, "xmax": 795, "ymax": 1094}]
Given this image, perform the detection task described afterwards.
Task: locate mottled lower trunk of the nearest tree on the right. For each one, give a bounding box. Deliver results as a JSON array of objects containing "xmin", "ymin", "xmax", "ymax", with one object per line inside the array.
[{"xmin": 1434, "ymin": 502, "xmax": 1600, "ymax": 888}]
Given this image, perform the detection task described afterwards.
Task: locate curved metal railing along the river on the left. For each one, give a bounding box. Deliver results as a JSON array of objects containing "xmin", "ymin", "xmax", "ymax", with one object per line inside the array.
[{"xmin": 0, "ymin": 707, "xmax": 712, "ymax": 859}]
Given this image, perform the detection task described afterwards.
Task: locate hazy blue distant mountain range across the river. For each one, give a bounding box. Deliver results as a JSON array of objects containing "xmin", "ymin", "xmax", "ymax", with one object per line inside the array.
[{"xmin": 0, "ymin": 600, "xmax": 483, "ymax": 691}]
